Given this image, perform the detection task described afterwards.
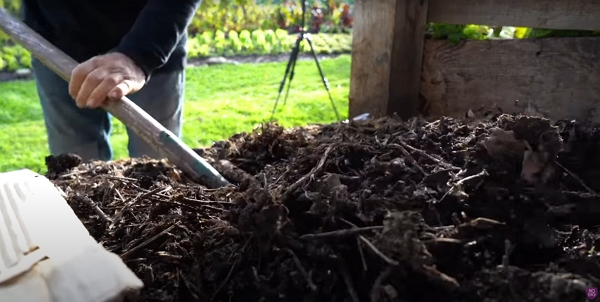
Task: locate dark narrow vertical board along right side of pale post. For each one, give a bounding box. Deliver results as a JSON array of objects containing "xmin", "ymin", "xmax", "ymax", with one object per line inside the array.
[{"xmin": 387, "ymin": 0, "xmax": 429, "ymax": 119}]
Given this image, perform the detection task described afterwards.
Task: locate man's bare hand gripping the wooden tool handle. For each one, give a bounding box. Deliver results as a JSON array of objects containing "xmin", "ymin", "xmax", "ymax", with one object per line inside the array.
[{"xmin": 69, "ymin": 52, "xmax": 146, "ymax": 108}]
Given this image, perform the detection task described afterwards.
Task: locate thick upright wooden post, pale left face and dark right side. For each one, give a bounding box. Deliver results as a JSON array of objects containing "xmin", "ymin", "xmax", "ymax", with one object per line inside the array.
[{"xmin": 350, "ymin": 0, "xmax": 428, "ymax": 118}]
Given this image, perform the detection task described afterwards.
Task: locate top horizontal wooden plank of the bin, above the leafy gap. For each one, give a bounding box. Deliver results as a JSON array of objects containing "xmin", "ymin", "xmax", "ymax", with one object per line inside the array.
[{"xmin": 428, "ymin": 0, "xmax": 600, "ymax": 30}]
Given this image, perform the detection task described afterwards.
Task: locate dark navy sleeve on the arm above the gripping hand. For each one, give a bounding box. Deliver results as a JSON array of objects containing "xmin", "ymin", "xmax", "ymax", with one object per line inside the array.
[{"xmin": 112, "ymin": 0, "xmax": 202, "ymax": 78}]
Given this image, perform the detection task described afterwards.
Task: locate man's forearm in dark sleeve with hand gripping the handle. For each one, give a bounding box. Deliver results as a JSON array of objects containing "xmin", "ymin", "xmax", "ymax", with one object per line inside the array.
[{"xmin": 69, "ymin": 0, "xmax": 201, "ymax": 108}]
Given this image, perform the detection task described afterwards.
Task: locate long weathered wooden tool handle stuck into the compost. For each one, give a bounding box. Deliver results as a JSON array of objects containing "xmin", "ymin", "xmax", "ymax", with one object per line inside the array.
[{"xmin": 0, "ymin": 8, "xmax": 229, "ymax": 188}]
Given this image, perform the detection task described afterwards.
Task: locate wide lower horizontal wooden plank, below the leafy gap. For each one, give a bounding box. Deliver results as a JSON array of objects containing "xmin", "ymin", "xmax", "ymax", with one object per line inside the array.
[{"xmin": 421, "ymin": 37, "xmax": 600, "ymax": 121}]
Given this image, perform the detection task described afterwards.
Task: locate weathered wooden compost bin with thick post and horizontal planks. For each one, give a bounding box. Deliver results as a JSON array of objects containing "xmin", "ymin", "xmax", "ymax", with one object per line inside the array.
[{"xmin": 350, "ymin": 0, "xmax": 600, "ymax": 121}]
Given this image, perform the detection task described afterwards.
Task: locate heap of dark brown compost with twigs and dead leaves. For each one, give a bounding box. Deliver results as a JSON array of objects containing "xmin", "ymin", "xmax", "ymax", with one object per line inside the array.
[{"xmin": 47, "ymin": 115, "xmax": 600, "ymax": 302}]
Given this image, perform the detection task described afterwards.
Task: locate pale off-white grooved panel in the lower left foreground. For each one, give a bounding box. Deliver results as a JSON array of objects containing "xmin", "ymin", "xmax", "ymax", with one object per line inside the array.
[{"xmin": 0, "ymin": 170, "xmax": 143, "ymax": 302}]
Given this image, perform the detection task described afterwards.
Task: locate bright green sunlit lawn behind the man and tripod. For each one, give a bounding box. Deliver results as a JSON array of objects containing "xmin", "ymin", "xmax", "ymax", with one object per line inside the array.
[{"xmin": 0, "ymin": 55, "xmax": 350, "ymax": 171}]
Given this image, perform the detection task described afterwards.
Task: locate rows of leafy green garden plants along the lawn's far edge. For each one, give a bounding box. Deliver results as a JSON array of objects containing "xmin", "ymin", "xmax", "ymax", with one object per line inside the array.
[{"xmin": 0, "ymin": 0, "xmax": 353, "ymax": 70}]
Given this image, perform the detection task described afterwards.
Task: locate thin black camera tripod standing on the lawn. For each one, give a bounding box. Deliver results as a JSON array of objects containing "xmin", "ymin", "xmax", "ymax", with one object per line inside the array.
[{"xmin": 271, "ymin": 0, "xmax": 340, "ymax": 121}]
